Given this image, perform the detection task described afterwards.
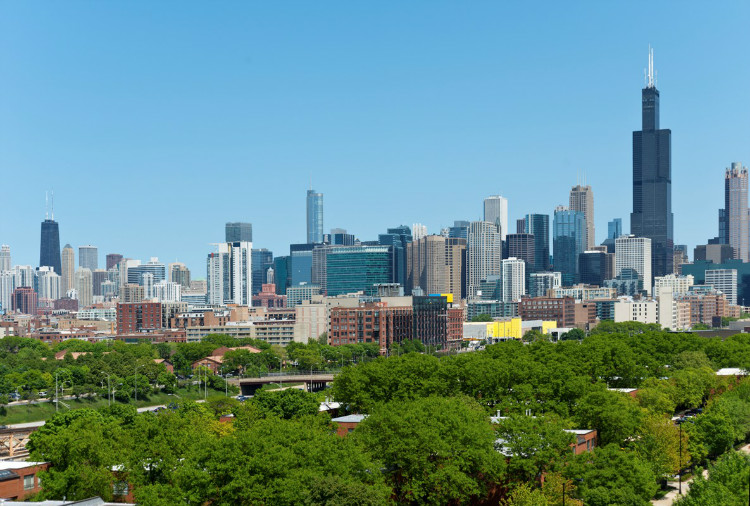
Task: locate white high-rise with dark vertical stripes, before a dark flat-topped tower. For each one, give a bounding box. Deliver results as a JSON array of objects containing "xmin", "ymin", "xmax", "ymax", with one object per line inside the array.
[{"xmin": 206, "ymin": 241, "xmax": 253, "ymax": 306}]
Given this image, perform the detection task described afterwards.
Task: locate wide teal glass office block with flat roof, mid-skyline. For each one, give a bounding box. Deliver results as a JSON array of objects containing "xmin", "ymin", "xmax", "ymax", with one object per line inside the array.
[{"xmin": 326, "ymin": 245, "xmax": 393, "ymax": 296}]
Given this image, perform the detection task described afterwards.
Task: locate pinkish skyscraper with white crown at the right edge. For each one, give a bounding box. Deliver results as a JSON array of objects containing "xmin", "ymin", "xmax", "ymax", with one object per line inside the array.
[{"xmin": 719, "ymin": 162, "xmax": 750, "ymax": 262}]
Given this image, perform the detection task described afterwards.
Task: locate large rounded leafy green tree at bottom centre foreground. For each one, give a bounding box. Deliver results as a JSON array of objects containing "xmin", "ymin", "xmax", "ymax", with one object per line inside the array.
[{"xmin": 356, "ymin": 397, "xmax": 504, "ymax": 504}]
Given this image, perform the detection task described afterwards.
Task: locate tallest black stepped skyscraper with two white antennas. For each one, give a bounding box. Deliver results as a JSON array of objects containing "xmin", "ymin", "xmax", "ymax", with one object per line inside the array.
[{"xmin": 630, "ymin": 48, "xmax": 674, "ymax": 276}]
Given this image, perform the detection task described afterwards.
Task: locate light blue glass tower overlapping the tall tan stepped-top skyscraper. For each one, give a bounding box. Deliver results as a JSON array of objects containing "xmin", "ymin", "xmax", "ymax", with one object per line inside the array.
[{"xmin": 552, "ymin": 206, "xmax": 586, "ymax": 286}]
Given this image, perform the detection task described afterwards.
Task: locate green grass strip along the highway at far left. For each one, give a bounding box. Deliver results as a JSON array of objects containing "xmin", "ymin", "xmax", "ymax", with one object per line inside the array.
[{"xmin": 0, "ymin": 388, "xmax": 224, "ymax": 425}]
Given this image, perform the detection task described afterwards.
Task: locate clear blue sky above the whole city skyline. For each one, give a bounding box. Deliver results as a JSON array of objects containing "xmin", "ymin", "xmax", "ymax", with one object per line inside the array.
[{"xmin": 0, "ymin": 1, "xmax": 750, "ymax": 278}]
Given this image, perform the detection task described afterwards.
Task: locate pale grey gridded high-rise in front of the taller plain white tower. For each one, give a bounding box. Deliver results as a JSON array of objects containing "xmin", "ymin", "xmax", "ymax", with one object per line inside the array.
[{"xmin": 466, "ymin": 221, "xmax": 503, "ymax": 298}]
